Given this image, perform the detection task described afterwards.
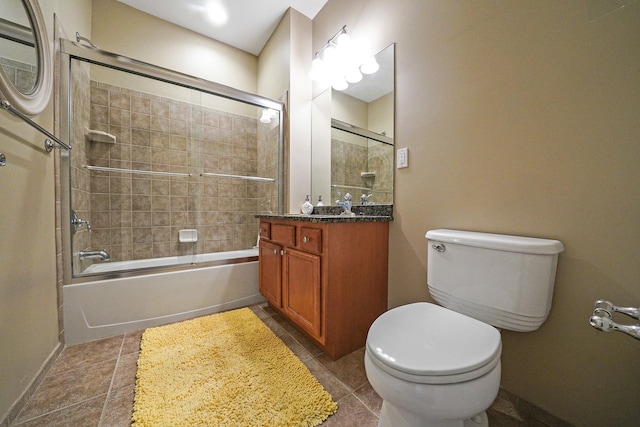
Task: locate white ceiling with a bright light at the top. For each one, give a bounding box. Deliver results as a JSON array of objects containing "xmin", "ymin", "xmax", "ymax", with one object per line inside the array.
[{"xmin": 118, "ymin": 0, "xmax": 327, "ymax": 56}]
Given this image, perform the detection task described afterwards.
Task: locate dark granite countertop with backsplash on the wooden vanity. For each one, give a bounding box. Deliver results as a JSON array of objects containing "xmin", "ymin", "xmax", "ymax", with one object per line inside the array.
[{"xmin": 256, "ymin": 205, "xmax": 393, "ymax": 223}]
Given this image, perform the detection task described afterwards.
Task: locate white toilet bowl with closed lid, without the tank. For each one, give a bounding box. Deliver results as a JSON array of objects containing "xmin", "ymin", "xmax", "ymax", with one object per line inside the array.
[{"xmin": 365, "ymin": 303, "xmax": 502, "ymax": 427}]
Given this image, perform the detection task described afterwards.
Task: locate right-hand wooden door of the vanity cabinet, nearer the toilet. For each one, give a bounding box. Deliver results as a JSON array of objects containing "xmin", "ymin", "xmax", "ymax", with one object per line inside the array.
[{"xmin": 282, "ymin": 248, "xmax": 322, "ymax": 340}]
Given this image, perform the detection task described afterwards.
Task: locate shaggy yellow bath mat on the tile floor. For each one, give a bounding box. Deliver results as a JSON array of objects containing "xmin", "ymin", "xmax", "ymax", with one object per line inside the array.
[{"xmin": 132, "ymin": 308, "xmax": 337, "ymax": 427}]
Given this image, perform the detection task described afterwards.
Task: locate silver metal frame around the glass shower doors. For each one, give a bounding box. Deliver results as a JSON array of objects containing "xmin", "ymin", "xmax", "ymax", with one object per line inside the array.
[{"xmin": 59, "ymin": 38, "xmax": 285, "ymax": 284}]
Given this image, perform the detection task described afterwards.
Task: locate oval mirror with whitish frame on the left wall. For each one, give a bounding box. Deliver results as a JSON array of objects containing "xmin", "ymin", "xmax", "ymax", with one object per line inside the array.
[{"xmin": 0, "ymin": 0, "xmax": 53, "ymax": 116}]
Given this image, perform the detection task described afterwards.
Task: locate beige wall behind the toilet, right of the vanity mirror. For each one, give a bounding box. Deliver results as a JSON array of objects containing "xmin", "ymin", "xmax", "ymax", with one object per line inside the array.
[{"xmin": 313, "ymin": 0, "xmax": 640, "ymax": 426}]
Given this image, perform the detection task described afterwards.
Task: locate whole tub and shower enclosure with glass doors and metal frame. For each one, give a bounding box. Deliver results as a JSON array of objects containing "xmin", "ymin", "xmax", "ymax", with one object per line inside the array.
[{"xmin": 60, "ymin": 35, "xmax": 284, "ymax": 344}]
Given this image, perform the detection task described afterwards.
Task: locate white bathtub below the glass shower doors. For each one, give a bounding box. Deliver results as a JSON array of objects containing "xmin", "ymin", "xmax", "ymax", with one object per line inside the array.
[{"xmin": 62, "ymin": 249, "xmax": 265, "ymax": 345}]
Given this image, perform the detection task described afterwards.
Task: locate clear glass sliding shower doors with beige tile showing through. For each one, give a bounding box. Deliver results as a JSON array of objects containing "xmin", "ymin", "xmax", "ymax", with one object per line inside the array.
[{"xmin": 63, "ymin": 54, "xmax": 281, "ymax": 277}]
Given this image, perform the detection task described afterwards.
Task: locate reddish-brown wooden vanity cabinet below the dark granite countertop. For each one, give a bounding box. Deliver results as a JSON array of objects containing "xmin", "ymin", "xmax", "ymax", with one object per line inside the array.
[{"xmin": 259, "ymin": 218, "xmax": 389, "ymax": 359}]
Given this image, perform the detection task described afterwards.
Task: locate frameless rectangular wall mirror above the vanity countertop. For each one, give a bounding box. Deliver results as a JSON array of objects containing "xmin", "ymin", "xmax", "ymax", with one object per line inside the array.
[{"xmin": 311, "ymin": 45, "xmax": 395, "ymax": 206}]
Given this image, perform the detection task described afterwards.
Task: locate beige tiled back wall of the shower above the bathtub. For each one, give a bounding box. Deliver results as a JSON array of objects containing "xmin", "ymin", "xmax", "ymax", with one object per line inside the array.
[{"xmin": 86, "ymin": 81, "xmax": 262, "ymax": 260}]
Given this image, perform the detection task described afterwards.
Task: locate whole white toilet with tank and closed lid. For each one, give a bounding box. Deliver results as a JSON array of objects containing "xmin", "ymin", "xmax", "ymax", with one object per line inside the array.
[{"xmin": 364, "ymin": 229, "xmax": 564, "ymax": 427}]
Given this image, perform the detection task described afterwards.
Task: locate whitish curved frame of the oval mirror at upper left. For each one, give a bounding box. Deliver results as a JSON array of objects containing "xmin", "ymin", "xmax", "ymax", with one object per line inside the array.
[{"xmin": 0, "ymin": 0, "xmax": 53, "ymax": 116}]
